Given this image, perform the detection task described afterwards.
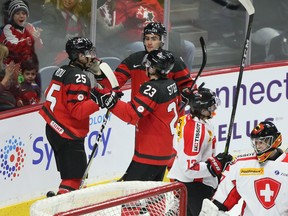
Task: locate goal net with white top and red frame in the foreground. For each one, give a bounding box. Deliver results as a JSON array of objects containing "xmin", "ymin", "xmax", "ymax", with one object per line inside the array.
[{"xmin": 30, "ymin": 181, "xmax": 187, "ymax": 216}]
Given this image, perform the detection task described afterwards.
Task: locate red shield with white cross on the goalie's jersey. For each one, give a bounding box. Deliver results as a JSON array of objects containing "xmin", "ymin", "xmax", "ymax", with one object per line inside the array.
[{"xmin": 254, "ymin": 178, "xmax": 281, "ymax": 209}]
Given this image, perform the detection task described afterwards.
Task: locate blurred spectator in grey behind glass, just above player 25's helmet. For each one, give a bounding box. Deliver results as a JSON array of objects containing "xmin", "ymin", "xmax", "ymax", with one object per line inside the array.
[{"xmin": 40, "ymin": 0, "xmax": 88, "ymax": 66}]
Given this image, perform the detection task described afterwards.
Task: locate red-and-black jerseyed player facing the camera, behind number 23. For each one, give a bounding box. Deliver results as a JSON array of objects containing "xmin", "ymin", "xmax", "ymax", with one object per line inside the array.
[{"xmin": 98, "ymin": 22, "xmax": 192, "ymax": 106}]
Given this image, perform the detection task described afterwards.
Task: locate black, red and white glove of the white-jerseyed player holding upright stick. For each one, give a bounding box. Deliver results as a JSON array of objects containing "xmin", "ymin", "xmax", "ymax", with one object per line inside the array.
[{"xmin": 206, "ymin": 153, "xmax": 233, "ymax": 179}]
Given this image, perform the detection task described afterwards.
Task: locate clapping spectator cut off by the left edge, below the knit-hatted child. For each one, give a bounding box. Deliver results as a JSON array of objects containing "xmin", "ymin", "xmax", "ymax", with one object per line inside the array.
[{"xmin": 0, "ymin": 44, "xmax": 20, "ymax": 111}]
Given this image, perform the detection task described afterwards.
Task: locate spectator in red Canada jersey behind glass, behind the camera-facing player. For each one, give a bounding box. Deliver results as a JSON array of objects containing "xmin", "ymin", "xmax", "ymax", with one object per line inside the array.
[{"xmin": 97, "ymin": 0, "xmax": 195, "ymax": 71}]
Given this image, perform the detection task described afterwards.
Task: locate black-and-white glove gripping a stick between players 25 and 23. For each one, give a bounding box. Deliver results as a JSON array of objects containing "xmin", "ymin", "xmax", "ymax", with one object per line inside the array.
[{"xmin": 90, "ymin": 87, "xmax": 124, "ymax": 109}]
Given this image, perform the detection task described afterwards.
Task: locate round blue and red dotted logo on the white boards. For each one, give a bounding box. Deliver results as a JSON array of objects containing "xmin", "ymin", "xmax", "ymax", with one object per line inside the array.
[{"xmin": 0, "ymin": 136, "xmax": 26, "ymax": 181}]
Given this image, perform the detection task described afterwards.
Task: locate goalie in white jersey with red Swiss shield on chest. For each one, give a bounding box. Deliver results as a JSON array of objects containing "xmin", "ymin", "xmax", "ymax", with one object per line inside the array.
[{"xmin": 201, "ymin": 121, "xmax": 288, "ymax": 216}]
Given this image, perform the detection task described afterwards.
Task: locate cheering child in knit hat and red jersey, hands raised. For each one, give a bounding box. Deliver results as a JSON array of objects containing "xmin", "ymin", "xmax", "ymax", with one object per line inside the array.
[{"xmin": 0, "ymin": 0, "xmax": 42, "ymax": 63}]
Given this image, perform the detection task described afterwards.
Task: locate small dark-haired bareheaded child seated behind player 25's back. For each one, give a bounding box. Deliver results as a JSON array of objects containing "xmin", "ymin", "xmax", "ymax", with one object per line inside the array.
[{"xmin": 17, "ymin": 60, "xmax": 41, "ymax": 106}]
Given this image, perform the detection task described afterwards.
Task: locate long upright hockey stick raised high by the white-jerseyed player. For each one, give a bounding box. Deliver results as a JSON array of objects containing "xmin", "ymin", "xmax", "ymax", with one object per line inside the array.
[{"xmin": 224, "ymin": 0, "xmax": 255, "ymax": 154}]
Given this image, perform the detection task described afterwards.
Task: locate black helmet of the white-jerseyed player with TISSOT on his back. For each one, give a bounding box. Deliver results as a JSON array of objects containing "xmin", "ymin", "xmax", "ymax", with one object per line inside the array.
[{"xmin": 189, "ymin": 85, "xmax": 220, "ymax": 118}]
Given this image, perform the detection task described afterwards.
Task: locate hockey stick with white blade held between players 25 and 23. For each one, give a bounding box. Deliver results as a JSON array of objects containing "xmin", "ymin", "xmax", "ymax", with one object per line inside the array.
[{"xmin": 79, "ymin": 62, "xmax": 119, "ymax": 189}]
